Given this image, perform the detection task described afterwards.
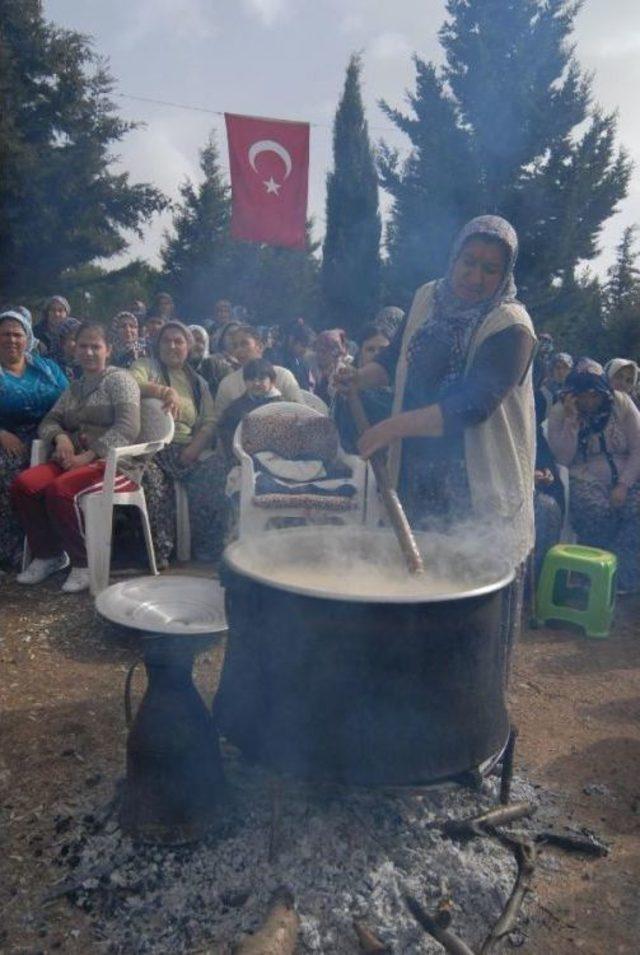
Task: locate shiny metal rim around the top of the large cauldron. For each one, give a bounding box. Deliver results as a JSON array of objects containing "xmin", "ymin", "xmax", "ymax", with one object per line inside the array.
[{"xmin": 223, "ymin": 527, "xmax": 515, "ymax": 605}]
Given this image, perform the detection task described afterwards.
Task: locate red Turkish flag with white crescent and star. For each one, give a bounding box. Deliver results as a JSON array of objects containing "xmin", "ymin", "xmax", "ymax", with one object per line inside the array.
[{"xmin": 224, "ymin": 113, "xmax": 309, "ymax": 249}]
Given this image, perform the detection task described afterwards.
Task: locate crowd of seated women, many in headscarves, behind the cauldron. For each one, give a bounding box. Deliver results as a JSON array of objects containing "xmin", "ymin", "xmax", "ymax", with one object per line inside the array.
[{"xmin": 0, "ymin": 293, "xmax": 640, "ymax": 592}]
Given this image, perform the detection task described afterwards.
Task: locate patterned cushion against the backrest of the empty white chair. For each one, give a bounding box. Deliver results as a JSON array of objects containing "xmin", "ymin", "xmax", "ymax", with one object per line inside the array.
[{"xmin": 242, "ymin": 413, "xmax": 338, "ymax": 464}]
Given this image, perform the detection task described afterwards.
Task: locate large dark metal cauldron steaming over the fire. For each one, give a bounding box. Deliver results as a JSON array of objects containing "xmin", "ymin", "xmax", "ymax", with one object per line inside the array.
[{"xmin": 214, "ymin": 528, "xmax": 513, "ymax": 786}]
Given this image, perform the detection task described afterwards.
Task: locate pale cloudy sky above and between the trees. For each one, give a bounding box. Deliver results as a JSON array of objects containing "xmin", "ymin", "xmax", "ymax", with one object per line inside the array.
[{"xmin": 44, "ymin": 0, "xmax": 640, "ymax": 274}]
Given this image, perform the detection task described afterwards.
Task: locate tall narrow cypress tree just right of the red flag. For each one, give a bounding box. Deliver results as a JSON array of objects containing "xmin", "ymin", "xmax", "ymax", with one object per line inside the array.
[{"xmin": 322, "ymin": 56, "xmax": 381, "ymax": 332}]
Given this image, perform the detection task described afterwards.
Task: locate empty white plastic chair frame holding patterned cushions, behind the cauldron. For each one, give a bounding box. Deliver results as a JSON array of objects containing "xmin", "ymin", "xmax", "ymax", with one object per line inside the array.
[{"xmin": 233, "ymin": 401, "xmax": 368, "ymax": 538}]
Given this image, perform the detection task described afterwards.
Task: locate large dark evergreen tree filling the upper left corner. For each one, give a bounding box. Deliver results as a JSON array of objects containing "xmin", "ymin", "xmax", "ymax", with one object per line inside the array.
[{"xmin": 0, "ymin": 0, "xmax": 166, "ymax": 299}]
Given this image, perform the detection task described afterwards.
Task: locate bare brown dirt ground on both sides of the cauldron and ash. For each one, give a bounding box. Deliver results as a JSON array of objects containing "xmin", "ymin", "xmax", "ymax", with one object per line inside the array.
[{"xmin": 0, "ymin": 578, "xmax": 640, "ymax": 955}]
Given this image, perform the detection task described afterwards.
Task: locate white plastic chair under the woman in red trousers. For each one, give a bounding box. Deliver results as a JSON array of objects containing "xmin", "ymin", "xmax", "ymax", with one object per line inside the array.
[{"xmin": 80, "ymin": 398, "xmax": 174, "ymax": 597}]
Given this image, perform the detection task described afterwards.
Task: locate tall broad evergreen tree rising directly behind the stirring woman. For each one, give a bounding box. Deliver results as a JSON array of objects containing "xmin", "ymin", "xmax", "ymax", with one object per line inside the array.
[{"xmin": 382, "ymin": 0, "xmax": 630, "ymax": 324}]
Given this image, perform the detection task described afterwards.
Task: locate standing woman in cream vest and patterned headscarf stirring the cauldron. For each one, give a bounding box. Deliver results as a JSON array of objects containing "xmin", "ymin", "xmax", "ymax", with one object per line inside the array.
[{"xmin": 338, "ymin": 216, "xmax": 535, "ymax": 636}]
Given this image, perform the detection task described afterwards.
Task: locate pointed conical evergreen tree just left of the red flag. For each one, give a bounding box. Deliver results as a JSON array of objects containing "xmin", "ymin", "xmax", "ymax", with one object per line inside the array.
[{"xmin": 162, "ymin": 134, "xmax": 233, "ymax": 321}]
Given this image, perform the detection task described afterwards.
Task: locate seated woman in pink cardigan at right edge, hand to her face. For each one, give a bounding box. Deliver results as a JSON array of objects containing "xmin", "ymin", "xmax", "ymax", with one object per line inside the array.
[{"xmin": 549, "ymin": 358, "xmax": 640, "ymax": 592}]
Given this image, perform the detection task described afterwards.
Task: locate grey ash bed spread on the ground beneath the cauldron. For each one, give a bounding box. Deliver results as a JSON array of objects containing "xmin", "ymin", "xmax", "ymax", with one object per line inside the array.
[{"xmin": 47, "ymin": 759, "xmax": 535, "ymax": 955}]
